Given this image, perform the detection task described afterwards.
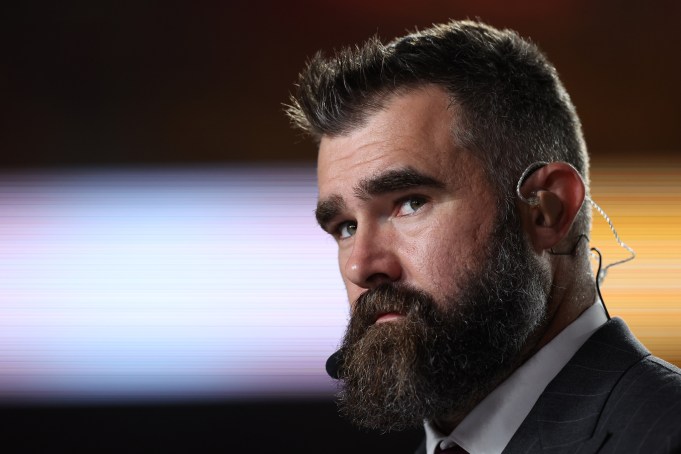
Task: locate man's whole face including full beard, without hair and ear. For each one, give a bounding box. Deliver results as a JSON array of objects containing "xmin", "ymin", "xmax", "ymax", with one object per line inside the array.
[{"xmin": 317, "ymin": 87, "xmax": 549, "ymax": 430}]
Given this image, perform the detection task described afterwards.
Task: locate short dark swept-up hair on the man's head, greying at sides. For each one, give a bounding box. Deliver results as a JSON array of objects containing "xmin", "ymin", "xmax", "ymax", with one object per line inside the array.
[{"xmin": 287, "ymin": 21, "xmax": 590, "ymax": 233}]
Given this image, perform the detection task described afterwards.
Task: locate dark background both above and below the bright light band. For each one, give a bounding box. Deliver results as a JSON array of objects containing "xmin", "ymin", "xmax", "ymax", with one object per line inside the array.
[{"xmin": 0, "ymin": 0, "xmax": 681, "ymax": 453}]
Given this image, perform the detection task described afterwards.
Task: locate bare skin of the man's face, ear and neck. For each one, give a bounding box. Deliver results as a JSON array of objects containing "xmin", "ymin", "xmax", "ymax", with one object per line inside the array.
[{"xmin": 317, "ymin": 85, "xmax": 595, "ymax": 433}]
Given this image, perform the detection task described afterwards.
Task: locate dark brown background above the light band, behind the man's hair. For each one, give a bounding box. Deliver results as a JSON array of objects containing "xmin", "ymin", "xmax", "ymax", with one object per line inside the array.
[{"xmin": 0, "ymin": 0, "xmax": 681, "ymax": 167}]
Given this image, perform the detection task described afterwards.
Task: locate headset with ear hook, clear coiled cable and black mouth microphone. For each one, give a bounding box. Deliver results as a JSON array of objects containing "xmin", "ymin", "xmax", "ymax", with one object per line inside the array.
[{"xmin": 326, "ymin": 161, "xmax": 636, "ymax": 380}]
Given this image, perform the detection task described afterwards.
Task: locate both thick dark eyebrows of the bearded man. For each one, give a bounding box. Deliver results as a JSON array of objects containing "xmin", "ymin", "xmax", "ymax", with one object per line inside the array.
[{"xmin": 315, "ymin": 167, "xmax": 445, "ymax": 232}]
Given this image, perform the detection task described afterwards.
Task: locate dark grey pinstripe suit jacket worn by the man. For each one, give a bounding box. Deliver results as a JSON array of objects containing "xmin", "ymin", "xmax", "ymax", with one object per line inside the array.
[{"xmin": 416, "ymin": 318, "xmax": 681, "ymax": 454}]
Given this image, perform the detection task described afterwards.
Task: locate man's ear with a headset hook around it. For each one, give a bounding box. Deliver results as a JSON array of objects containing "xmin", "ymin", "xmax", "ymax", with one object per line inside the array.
[{"xmin": 519, "ymin": 162, "xmax": 585, "ymax": 252}]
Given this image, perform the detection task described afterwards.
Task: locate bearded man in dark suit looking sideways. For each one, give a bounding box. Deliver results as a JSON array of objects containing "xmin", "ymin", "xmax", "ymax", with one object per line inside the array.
[{"xmin": 288, "ymin": 21, "xmax": 681, "ymax": 454}]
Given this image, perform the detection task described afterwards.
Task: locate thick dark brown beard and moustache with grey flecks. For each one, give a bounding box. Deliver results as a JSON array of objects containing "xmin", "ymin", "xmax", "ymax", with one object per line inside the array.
[{"xmin": 338, "ymin": 218, "xmax": 550, "ymax": 431}]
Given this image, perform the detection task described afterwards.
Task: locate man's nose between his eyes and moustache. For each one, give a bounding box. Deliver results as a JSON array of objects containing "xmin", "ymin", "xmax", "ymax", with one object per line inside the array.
[{"xmin": 344, "ymin": 227, "xmax": 402, "ymax": 289}]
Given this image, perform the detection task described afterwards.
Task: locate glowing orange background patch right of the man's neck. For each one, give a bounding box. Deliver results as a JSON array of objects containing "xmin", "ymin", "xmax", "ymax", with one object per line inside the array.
[{"xmin": 591, "ymin": 153, "xmax": 681, "ymax": 366}]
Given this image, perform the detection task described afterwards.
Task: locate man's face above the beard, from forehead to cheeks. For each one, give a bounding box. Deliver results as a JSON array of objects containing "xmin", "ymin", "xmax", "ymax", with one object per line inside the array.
[{"xmin": 317, "ymin": 86, "xmax": 496, "ymax": 308}]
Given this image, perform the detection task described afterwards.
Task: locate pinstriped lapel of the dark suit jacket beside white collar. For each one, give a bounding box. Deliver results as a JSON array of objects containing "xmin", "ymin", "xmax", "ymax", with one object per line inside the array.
[{"xmin": 504, "ymin": 319, "xmax": 650, "ymax": 453}]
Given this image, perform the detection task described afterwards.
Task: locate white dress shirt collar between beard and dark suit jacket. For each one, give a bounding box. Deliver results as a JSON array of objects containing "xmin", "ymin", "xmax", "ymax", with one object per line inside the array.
[{"xmin": 425, "ymin": 300, "xmax": 608, "ymax": 454}]
